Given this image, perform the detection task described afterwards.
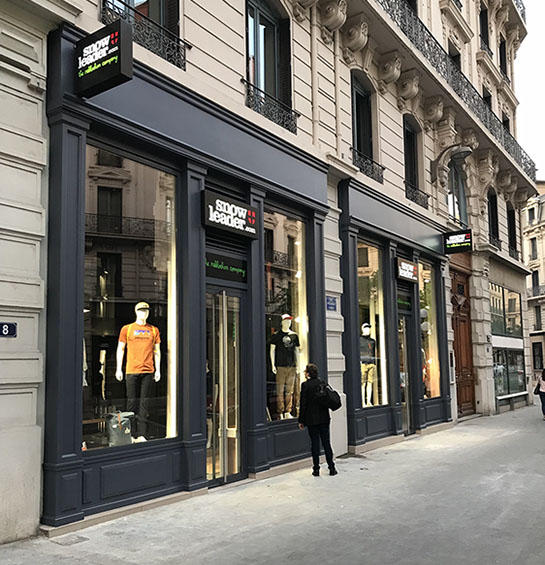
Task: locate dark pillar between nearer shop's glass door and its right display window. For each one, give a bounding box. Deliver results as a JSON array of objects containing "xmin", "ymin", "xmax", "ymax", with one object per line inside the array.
[{"xmin": 247, "ymin": 186, "xmax": 270, "ymax": 474}]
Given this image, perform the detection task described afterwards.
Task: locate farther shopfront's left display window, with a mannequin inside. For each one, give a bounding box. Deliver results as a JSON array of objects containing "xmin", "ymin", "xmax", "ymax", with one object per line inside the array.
[{"xmin": 358, "ymin": 241, "xmax": 388, "ymax": 407}]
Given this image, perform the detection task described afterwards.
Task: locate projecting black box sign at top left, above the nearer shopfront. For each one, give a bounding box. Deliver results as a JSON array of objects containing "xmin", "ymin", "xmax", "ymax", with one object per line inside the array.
[{"xmin": 76, "ymin": 20, "xmax": 133, "ymax": 97}]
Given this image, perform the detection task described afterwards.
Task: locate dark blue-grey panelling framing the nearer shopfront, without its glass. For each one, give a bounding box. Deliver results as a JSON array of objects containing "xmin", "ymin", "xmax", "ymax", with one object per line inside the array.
[{"xmin": 43, "ymin": 26, "xmax": 327, "ymax": 526}]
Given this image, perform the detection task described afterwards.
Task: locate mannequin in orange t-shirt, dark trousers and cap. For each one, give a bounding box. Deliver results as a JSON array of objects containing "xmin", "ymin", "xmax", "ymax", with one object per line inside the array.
[{"xmin": 115, "ymin": 302, "xmax": 161, "ymax": 442}]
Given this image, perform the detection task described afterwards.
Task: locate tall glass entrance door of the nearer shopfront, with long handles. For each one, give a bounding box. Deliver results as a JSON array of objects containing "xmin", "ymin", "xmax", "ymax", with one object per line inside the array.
[{"xmin": 206, "ymin": 290, "xmax": 242, "ymax": 483}]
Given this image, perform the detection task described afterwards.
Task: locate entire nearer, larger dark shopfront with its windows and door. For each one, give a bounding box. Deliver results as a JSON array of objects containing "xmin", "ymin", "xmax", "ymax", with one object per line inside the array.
[{"xmin": 42, "ymin": 22, "xmax": 327, "ymax": 526}]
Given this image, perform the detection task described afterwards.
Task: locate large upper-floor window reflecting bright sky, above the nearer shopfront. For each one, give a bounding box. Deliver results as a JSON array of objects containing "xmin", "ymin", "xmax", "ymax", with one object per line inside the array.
[{"xmin": 247, "ymin": 0, "xmax": 291, "ymax": 106}]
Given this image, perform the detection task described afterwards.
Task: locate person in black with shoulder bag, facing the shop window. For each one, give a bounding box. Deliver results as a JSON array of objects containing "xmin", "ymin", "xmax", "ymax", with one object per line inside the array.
[{"xmin": 299, "ymin": 363, "xmax": 337, "ymax": 477}]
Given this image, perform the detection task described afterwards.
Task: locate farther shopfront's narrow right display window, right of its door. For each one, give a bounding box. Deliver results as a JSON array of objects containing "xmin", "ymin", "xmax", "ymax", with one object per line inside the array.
[{"xmin": 418, "ymin": 262, "xmax": 441, "ymax": 398}]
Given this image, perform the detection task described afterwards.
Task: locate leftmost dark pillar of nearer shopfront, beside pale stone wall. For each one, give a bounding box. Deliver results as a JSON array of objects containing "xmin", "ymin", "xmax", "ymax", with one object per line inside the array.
[{"xmin": 42, "ymin": 110, "xmax": 89, "ymax": 526}]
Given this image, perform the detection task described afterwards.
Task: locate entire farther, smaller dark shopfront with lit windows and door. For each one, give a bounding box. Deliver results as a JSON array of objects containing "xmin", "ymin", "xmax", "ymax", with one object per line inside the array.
[{"xmin": 339, "ymin": 181, "xmax": 451, "ymax": 452}]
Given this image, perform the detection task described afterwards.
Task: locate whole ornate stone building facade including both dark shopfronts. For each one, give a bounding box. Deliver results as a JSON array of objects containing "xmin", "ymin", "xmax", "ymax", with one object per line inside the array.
[{"xmin": 0, "ymin": 0, "xmax": 535, "ymax": 541}]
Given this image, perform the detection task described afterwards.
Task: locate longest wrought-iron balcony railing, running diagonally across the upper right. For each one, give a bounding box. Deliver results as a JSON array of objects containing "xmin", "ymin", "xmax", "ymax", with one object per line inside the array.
[{"xmin": 376, "ymin": 0, "xmax": 536, "ymax": 181}]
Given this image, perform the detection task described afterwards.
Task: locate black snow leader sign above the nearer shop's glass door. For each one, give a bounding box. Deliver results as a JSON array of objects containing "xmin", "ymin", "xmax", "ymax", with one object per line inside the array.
[{"xmin": 203, "ymin": 190, "xmax": 260, "ymax": 239}]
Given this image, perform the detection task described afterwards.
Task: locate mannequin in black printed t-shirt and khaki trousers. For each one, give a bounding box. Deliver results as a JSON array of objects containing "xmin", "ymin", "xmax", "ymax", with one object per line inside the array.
[{"xmin": 270, "ymin": 314, "xmax": 301, "ymax": 419}]
